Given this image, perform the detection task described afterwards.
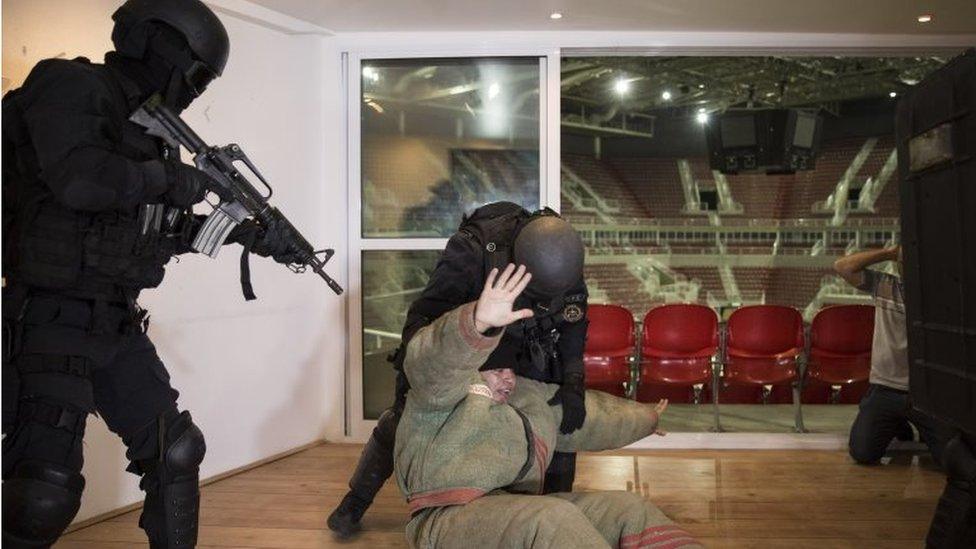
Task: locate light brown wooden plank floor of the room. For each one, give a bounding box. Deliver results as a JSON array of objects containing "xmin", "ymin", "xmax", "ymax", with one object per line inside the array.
[{"xmin": 55, "ymin": 444, "xmax": 944, "ymax": 549}]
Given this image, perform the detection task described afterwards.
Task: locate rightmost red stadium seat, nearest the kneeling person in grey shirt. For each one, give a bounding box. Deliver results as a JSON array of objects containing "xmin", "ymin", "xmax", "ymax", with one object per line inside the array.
[{"xmin": 807, "ymin": 305, "xmax": 874, "ymax": 400}]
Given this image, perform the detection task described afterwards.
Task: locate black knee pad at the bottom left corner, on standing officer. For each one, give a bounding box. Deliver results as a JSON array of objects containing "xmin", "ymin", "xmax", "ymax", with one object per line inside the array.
[{"xmin": 3, "ymin": 460, "xmax": 85, "ymax": 548}]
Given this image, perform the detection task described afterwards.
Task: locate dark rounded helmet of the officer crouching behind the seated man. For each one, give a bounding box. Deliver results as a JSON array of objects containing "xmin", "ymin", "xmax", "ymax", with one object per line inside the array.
[{"xmin": 515, "ymin": 215, "xmax": 584, "ymax": 298}]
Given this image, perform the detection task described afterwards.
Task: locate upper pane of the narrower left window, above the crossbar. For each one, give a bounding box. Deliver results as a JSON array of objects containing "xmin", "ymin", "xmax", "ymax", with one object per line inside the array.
[{"xmin": 361, "ymin": 58, "xmax": 540, "ymax": 238}]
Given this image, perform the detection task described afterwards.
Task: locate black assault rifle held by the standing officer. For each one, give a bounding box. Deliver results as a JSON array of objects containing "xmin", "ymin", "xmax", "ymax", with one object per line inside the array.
[{"xmin": 129, "ymin": 94, "xmax": 342, "ymax": 299}]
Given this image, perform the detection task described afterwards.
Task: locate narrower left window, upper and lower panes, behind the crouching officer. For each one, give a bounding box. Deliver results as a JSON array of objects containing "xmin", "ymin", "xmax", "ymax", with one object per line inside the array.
[{"xmin": 351, "ymin": 57, "xmax": 545, "ymax": 420}]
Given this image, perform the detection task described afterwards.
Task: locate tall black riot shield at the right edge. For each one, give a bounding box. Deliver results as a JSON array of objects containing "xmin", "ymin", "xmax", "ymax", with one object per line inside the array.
[{"xmin": 895, "ymin": 49, "xmax": 976, "ymax": 433}]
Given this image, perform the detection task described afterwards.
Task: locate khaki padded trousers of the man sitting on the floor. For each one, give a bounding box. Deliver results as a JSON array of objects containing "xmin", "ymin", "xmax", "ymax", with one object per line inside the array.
[{"xmin": 407, "ymin": 492, "xmax": 700, "ymax": 549}]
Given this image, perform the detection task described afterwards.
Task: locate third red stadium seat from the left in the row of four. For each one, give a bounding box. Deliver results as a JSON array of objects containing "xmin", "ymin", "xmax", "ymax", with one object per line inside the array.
[{"xmin": 723, "ymin": 305, "xmax": 804, "ymax": 431}]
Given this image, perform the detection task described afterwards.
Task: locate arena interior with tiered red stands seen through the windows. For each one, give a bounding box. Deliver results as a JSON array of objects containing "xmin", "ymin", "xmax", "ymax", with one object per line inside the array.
[{"xmin": 362, "ymin": 56, "xmax": 945, "ymax": 433}]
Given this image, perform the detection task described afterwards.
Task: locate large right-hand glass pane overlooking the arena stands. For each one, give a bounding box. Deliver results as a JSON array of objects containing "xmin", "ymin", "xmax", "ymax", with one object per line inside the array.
[{"xmin": 560, "ymin": 55, "xmax": 945, "ymax": 436}]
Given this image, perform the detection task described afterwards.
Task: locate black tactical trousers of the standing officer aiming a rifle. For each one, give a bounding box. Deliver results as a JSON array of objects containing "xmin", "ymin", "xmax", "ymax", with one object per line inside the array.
[{"xmin": 3, "ymin": 289, "xmax": 187, "ymax": 547}]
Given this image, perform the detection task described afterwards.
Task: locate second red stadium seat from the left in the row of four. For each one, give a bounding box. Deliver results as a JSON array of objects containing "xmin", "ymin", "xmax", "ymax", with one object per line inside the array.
[{"xmin": 637, "ymin": 304, "xmax": 719, "ymax": 428}]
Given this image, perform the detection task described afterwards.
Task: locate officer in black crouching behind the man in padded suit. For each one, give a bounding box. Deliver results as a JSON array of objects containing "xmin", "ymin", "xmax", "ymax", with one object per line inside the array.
[{"xmin": 328, "ymin": 202, "xmax": 587, "ymax": 537}]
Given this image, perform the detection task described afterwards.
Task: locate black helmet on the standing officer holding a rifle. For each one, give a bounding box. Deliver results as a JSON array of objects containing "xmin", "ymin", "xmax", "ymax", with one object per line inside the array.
[{"xmin": 112, "ymin": 0, "xmax": 230, "ymax": 97}]
